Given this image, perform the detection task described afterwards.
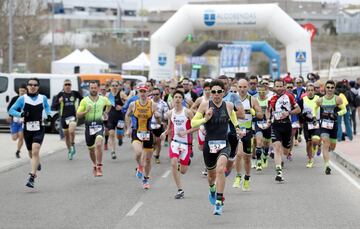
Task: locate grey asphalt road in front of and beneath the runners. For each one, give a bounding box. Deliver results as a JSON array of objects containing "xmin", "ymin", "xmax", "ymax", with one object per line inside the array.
[{"xmin": 0, "ymin": 137, "xmax": 360, "ymax": 229}]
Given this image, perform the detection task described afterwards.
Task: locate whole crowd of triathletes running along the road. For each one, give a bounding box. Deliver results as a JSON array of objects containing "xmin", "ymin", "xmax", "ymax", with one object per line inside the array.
[{"xmin": 8, "ymin": 74, "xmax": 360, "ymax": 215}]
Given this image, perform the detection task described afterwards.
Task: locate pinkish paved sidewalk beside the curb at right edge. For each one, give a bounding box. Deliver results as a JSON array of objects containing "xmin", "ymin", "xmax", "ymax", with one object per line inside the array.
[{"xmin": 332, "ymin": 134, "xmax": 360, "ymax": 178}]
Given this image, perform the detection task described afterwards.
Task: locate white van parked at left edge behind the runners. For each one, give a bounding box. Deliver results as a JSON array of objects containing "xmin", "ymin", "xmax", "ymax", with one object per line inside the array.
[{"xmin": 0, "ymin": 73, "xmax": 79, "ymax": 132}]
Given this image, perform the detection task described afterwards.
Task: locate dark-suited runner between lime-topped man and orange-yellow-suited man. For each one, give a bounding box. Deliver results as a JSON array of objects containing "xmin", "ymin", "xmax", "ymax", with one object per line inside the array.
[{"xmin": 107, "ymin": 81, "xmax": 125, "ymax": 160}]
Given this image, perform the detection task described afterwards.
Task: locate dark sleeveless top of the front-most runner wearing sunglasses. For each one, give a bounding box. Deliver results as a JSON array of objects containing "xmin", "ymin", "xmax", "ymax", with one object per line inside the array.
[{"xmin": 204, "ymin": 100, "xmax": 230, "ymax": 141}]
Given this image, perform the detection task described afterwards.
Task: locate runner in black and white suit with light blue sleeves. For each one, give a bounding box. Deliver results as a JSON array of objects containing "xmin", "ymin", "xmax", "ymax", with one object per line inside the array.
[{"xmin": 9, "ymin": 78, "xmax": 51, "ymax": 188}]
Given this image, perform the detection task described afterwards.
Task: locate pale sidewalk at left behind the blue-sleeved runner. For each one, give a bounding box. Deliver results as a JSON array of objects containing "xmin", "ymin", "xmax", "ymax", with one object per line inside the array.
[{"xmin": 0, "ymin": 128, "xmax": 85, "ymax": 172}]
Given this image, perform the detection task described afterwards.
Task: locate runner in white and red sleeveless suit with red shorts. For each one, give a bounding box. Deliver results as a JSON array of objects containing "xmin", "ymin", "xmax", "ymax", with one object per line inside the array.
[{"xmin": 161, "ymin": 91, "xmax": 198, "ymax": 199}]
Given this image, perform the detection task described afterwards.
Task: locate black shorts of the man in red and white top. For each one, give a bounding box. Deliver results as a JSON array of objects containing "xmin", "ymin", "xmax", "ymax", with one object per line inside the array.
[{"xmin": 271, "ymin": 122, "xmax": 292, "ymax": 149}]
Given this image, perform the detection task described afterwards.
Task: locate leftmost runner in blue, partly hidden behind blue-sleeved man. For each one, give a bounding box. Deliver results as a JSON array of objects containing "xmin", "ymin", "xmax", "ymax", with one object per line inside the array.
[{"xmin": 7, "ymin": 84, "xmax": 26, "ymax": 158}]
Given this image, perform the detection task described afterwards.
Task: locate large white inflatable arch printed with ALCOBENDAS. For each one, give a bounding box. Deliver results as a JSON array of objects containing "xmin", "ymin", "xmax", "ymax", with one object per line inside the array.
[{"xmin": 149, "ymin": 4, "xmax": 312, "ymax": 80}]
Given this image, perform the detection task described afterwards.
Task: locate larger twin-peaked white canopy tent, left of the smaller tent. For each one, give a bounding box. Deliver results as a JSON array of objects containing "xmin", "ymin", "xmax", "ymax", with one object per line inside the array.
[{"xmin": 51, "ymin": 49, "xmax": 109, "ymax": 74}]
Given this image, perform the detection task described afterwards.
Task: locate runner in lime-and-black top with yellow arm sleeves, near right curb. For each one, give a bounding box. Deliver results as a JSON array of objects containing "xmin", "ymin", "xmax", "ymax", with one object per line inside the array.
[{"xmin": 313, "ymin": 80, "xmax": 346, "ymax": 175}]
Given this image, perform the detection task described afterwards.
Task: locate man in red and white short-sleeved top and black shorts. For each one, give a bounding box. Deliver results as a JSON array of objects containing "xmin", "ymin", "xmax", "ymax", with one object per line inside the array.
[{"xmin": 268, "ymin": 79, "xmax": 300, "ymax": 182}]
